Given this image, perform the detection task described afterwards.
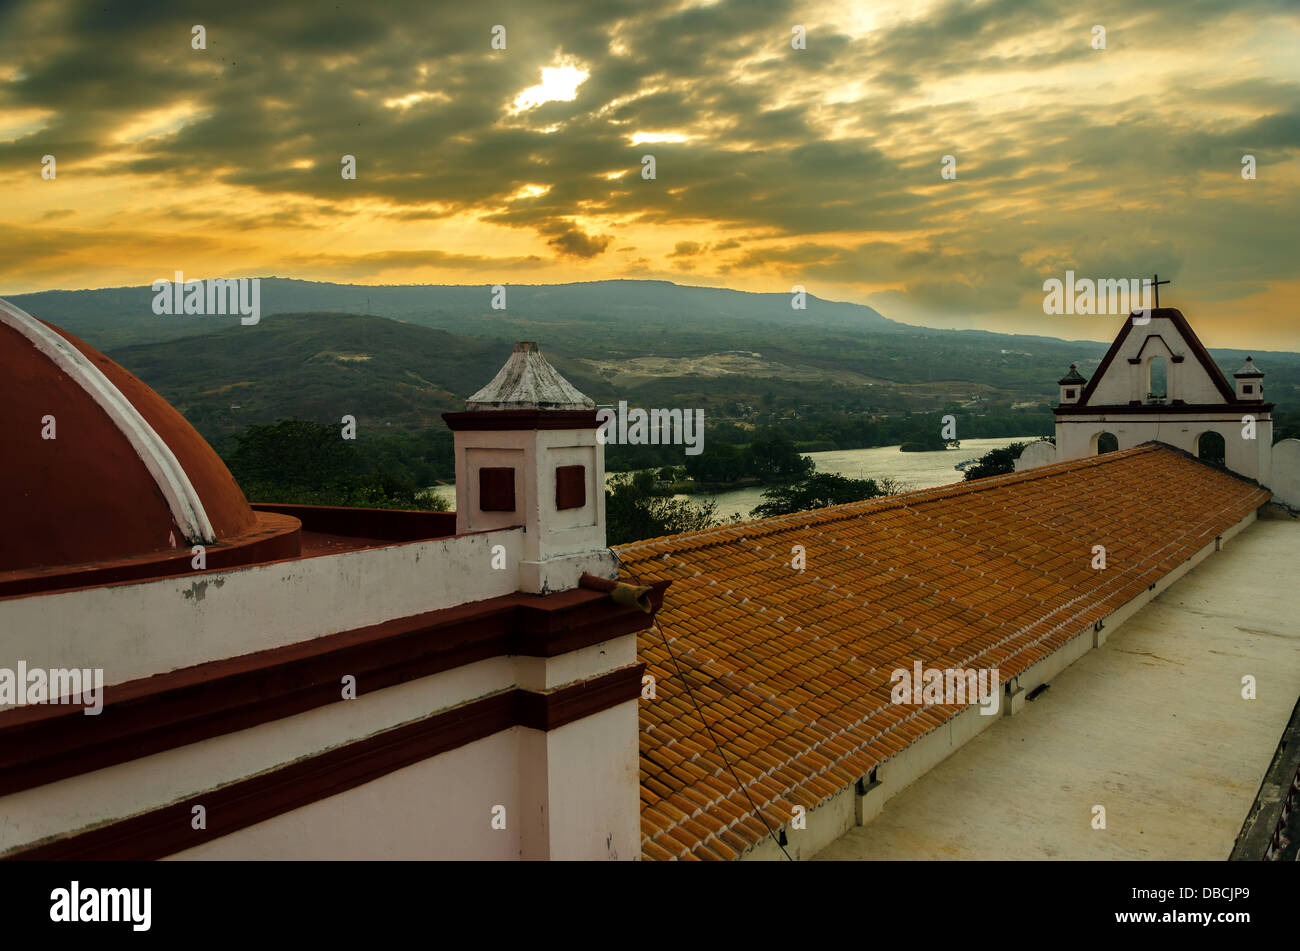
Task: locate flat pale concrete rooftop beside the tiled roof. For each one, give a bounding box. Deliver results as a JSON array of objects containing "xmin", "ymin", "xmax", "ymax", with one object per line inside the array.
[{"xmin": 815, "ymin": 520, "xmax": 1300, "ymax": 860}]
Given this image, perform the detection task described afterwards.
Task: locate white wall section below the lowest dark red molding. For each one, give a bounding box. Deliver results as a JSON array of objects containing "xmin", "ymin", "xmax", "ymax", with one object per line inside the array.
[{"xmin": 173, "ymin": 700, "xmax": 641, "ymax": 860}]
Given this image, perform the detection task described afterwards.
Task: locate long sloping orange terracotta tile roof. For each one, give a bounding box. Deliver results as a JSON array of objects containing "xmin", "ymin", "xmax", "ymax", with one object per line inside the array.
[{"xmin": 616, "ymin": 444, "xmax": 1269, "ymax": 859}]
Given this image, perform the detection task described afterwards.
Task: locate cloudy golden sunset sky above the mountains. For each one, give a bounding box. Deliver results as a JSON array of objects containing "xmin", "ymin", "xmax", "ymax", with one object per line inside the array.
[{"xmin": 0, "ymin": 0, "xmax": 1300, "ymax": 349}]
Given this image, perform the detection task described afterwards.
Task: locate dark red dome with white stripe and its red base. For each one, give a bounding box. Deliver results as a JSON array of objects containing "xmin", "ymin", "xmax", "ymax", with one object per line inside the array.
[{"xmin": 0, "ymin": 300, "xmax": 298, "ymax": 595}]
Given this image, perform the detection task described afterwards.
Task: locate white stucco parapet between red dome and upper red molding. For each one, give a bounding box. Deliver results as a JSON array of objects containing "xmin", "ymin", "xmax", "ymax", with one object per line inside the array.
[{"xmin": 0, "ymin": 529, "xmax": 523, "ymax": 683}]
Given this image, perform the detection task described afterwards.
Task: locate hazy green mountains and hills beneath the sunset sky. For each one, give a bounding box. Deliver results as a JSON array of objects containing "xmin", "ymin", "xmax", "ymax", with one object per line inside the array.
[{"xmin": 9, "ymin": 278, "xmax": 1300, "ymax": 449}]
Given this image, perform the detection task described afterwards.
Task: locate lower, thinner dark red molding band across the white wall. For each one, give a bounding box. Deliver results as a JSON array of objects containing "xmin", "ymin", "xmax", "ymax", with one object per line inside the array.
[{"xmin": 5, "ymin": 664, "xmax": 645, "ymax": 861}]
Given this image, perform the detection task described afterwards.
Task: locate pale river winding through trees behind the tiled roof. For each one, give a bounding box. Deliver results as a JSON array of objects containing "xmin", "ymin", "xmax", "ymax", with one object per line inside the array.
[{"xmin": 429, "ymin": 437, "xmax": 1039, "ymax": 518}]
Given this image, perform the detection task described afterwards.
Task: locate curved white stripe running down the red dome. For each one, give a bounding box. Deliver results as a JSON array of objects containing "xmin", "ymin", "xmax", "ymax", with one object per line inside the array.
[{"xmin": 0, "ymin": 298, "xmax": 217, "ymax": 543}]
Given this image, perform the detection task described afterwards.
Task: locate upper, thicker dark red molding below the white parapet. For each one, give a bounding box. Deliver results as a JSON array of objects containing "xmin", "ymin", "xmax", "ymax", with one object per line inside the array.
[{"xmin": 0, "ymin": 582, "xmax": 668, "ymax": 795}]
